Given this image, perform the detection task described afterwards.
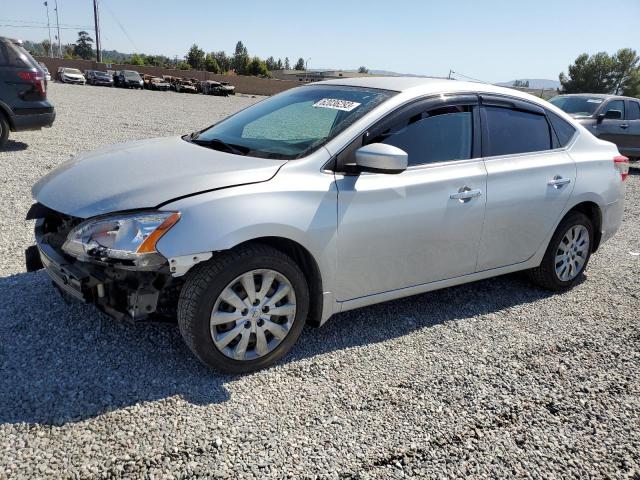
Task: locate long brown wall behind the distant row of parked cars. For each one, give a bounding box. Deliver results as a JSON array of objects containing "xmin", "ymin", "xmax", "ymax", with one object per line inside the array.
[{"xmin": 35, "ymin": 57, "xmax": 301, "ymax": 95}]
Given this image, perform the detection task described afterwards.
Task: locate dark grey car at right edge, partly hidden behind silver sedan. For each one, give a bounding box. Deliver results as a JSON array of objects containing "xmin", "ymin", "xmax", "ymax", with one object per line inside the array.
[{"xmin": 549, "ymin": 93, "xmax": 640, "ymax": 160}]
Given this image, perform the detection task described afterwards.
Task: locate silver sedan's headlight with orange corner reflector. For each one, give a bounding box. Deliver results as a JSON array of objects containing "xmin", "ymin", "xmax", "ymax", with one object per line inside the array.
[{"xmin": 62, "ymin": 212, "xmax": 180, "ymax": 268}]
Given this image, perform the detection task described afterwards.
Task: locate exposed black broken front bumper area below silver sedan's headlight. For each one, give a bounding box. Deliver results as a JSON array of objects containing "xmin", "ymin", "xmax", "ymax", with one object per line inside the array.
[{"xmin": 25, "ymin": 218, "xmax": 180, "ymax": 321}]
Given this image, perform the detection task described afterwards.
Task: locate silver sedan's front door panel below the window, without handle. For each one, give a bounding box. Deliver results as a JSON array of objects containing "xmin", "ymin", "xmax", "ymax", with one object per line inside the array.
[{"xmin": 336, "ymin": 159, "xmax": 486, "ymax": 300}]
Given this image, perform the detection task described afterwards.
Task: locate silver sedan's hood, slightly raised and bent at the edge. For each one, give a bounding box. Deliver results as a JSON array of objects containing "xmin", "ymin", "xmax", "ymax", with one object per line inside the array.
[{"xmin": 32, "ymin": 137, "xmax": 286, "ymax": 218}]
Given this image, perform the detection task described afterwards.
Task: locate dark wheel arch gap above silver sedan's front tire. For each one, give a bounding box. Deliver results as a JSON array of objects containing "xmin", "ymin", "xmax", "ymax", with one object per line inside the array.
[{"xmin": 234, "ymin": 236, "xmax": 323, "ymax": 327}]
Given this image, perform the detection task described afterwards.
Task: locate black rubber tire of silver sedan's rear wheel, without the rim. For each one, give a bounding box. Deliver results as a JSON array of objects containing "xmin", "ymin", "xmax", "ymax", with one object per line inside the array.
[{"xmin": 528, "ymin": 212, "xmax": 593, "ymax": 292}]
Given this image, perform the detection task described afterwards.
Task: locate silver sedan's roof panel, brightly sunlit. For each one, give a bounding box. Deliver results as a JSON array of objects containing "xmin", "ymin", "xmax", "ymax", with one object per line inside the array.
[{"xmin": 307, "ymin": 76, "xmax": 546, "ymax": 103}]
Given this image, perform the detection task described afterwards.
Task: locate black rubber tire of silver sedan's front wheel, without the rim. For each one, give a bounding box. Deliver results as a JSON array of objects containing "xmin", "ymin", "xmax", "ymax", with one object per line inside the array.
[{"xmin": 178, "ymin": 244, "xmax": 309, "ymax": 374}]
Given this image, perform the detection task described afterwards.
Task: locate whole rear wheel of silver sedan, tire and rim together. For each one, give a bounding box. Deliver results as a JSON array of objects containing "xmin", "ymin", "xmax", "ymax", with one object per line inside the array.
[{"xmin": 529, "ymin": 212, "xmax": 593, "ymax": 291}]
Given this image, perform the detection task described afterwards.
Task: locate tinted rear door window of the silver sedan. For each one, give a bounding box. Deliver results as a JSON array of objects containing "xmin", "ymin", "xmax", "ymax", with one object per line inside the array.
[{"xmin": 483, "ymin": 106, "xmax": 552, "ymax": 157}]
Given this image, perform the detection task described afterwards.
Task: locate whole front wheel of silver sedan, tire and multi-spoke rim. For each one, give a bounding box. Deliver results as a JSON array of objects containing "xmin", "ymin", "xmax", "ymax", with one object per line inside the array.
[{"xmin": 178, "ymin": 244, "xmax": 309, "ymax": 373}]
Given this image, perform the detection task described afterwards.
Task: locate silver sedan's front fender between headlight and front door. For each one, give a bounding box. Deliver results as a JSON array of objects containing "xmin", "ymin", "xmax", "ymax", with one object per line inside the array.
[{"xmin": 157, "ymin": 149, "xmax": 337, "ymax": 319}]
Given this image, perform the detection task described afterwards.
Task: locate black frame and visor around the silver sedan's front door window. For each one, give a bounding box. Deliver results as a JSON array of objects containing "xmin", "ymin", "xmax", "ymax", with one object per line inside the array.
[{"xmin": 328, "ymin": 92, "xmax": 482, "ymax": 174}]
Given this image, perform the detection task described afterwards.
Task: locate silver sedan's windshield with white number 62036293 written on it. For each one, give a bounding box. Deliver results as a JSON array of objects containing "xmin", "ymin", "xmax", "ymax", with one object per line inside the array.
[{"xmin": 188, "ymin": 85, "xmax": 394, "ymax": 159}]
